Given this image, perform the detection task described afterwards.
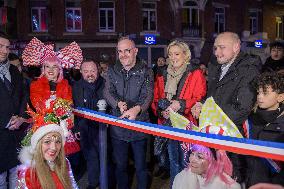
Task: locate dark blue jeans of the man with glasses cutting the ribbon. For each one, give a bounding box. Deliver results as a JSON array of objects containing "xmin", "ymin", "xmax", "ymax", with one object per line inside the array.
[{"xmin": 111, "ymin": 138, "xmax": 148, "ymax": 189}]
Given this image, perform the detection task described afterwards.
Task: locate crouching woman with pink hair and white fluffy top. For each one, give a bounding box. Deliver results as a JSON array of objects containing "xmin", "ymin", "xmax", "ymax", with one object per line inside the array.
[{"xmin": 172, "ymin": 145, "xmax": 241, "ymax": 189}]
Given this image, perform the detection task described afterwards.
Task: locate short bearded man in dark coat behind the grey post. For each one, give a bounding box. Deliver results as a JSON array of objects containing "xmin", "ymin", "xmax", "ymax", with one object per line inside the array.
[{"xmin": 72, "ymin": 60, "xmax": 104, "ymax": 189}]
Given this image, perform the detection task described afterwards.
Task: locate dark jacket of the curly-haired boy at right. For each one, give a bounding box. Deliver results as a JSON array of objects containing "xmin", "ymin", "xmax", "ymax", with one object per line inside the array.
[{"xmin": 247, "ymin": 105, "xmax": 284, "ymax": 187}]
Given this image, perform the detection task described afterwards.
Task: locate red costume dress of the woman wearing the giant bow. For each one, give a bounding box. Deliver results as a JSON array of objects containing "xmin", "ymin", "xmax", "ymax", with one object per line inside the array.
[{"xmin": 30, "ymin": 76, "xmax": 80, "ymax": 155}]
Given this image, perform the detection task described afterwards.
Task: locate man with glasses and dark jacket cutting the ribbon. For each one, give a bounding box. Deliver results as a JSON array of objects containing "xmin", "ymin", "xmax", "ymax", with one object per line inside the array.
[{"xmin": 104, "ymin": 37, "xmax": 153, "ymax": 189}]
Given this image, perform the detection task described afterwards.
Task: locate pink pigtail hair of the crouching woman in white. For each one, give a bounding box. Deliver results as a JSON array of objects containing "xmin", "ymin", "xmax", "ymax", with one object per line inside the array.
[{"xmin": 191, "ymin": 144, "xmax": 234, "ymax": 185}]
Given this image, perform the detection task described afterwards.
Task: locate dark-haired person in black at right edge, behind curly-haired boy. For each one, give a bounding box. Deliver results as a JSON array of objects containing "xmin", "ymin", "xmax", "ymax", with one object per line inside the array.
[{"xmin": 262, "ymin": 41, "xmax": 284, "ymax": 73}]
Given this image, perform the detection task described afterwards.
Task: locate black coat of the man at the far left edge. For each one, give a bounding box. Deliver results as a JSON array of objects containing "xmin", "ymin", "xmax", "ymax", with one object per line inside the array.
[{"xmin": 0, "ymin": 65, "xmax": 28, "ymax": 174}]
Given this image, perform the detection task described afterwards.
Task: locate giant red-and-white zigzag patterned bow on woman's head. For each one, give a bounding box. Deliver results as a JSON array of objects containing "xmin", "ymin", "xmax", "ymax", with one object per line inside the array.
[{"xmin": 22, "ymin": 37, "xmax": 83, "ymax": 69}]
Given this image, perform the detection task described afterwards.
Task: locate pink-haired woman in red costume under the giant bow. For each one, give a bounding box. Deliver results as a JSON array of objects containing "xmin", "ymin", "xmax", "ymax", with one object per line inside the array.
[{"xmin": 30, "ymin": 56, "xmax": 80, "ymax": 156}]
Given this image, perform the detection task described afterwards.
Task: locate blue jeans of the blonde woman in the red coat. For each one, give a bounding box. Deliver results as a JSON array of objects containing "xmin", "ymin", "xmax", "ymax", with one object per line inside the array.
[{"xmin": 168, "ymin": 140, "xmax": 186, "ymax": 187}]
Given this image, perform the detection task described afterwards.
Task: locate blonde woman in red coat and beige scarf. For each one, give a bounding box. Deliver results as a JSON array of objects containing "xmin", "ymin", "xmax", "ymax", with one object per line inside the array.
[{"xmin": 152, "ymin": 41, "xmax": 206, "ymax": 186}]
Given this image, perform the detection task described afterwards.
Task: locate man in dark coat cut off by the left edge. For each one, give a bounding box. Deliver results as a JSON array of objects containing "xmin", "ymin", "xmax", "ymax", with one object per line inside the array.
[{"xmin": 0, "ymin": 33, "xmax": 28, "ymax": 189}]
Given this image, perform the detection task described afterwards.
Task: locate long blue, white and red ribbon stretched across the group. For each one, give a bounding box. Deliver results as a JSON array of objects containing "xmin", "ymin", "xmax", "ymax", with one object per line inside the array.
[{"xmin": 74, "ymin": 108, "xmax": 284, "ymax": 161}]
